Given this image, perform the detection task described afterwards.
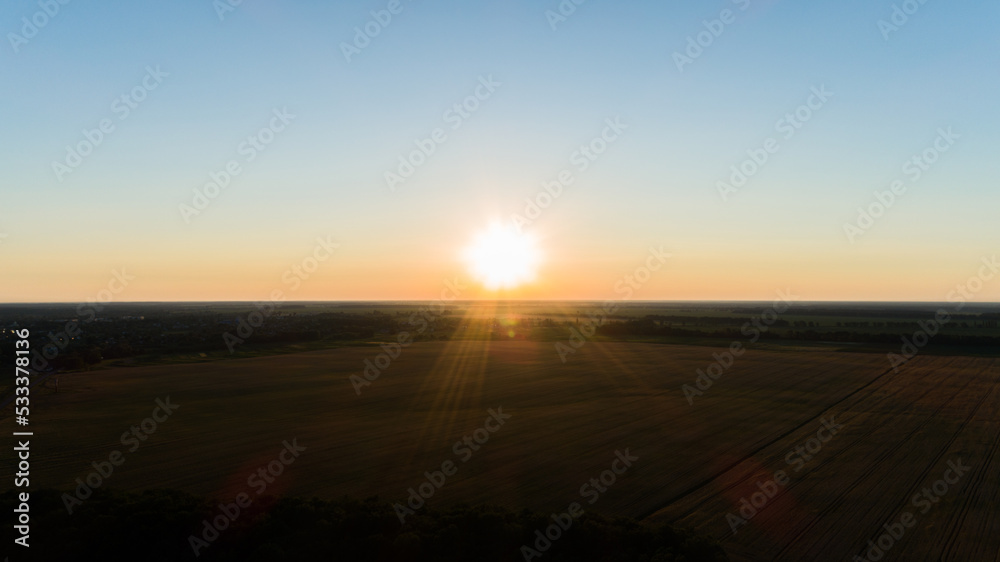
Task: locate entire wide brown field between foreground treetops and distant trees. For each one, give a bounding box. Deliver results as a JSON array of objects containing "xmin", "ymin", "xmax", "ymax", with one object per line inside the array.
[{"xmin": 17, "ymin": 339, "xmax": 1000, "ymax": 560}]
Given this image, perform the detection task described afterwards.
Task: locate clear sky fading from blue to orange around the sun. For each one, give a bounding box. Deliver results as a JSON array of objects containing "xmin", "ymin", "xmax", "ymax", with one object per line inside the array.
[{"xmin": 0, "ymin": 0, "xmax": 1000, "ymax": 302}]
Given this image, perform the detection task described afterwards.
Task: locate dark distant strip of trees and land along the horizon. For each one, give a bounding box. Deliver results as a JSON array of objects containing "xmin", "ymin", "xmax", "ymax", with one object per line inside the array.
[{"xmin": 7, "ymin": 304, "xmax": 1000, "ymax": 372}]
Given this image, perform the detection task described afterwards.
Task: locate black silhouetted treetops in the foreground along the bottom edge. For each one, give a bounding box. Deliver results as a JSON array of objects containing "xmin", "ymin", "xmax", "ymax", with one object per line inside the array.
[{"xmin": 0, "ymin": 489, "xmax": 728, "ymax": 562}]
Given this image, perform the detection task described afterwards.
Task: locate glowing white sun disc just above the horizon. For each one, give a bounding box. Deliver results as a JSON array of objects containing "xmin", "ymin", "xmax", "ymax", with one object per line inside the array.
[{"xmin": 464, "ymin": 224, "xmax": 541, "ymax": 291}]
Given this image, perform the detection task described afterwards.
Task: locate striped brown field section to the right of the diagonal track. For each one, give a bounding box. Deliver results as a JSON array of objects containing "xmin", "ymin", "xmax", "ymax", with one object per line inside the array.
[{"xmin": 650, "ymin": 357, "xmax": 1000, "ymax": 561}]
